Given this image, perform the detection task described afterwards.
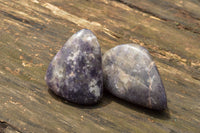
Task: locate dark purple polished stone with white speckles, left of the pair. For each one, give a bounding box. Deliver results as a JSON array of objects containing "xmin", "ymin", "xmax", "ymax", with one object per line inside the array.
[{"xmin": 46, "ymin": 29, "xmax": 103, "ymax": 104}]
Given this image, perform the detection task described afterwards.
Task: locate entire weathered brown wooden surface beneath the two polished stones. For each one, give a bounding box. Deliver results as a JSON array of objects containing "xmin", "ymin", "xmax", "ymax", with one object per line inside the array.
[{"xmin": 0, "ymin": 0, "xmax": 200, "ymax": 133}]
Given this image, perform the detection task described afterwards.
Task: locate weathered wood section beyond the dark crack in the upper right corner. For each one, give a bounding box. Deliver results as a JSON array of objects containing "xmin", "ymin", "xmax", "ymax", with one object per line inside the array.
[{"xmin": 117, "ymin": 0, "xmax": 200, "ymax": 34}]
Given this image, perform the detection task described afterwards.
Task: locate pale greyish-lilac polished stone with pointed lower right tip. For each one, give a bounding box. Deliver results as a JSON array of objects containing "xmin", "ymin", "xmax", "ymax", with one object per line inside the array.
[{"xmin": 103, "ymin": 44, "xmax": 167, "ymax": 110}]
